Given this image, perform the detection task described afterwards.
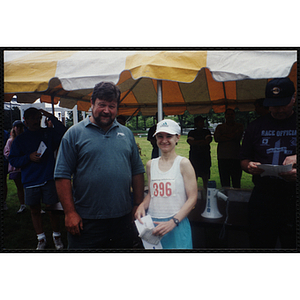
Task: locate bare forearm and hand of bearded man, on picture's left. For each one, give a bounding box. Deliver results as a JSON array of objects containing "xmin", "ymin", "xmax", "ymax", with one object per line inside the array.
[{"xmin": 55, "ymin": 178, "xmax": 83, "ymax": 235}]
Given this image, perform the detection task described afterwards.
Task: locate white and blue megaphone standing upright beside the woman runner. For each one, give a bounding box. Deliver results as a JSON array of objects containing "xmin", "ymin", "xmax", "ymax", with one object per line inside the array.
[{"xmin": 201, "ymin": 181, "xmax": 228, "ymax": 219}]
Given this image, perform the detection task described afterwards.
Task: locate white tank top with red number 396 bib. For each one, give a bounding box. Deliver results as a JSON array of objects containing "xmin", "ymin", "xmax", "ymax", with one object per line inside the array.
[{"xmin": 148, "ymin": 156, "xmax": 187, "ymax": 218}]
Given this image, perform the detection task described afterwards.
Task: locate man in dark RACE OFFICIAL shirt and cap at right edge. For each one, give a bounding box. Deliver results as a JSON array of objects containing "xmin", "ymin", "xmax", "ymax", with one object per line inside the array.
[{"xmin": 241, "ymin": 78, "xmax": 297, "ymax": 249}]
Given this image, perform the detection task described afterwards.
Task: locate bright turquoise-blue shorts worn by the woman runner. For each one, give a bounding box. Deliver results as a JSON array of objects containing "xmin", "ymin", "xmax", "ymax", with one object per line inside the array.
[{"xmin": 152, "ymin": 218, "xmax": 193, "ymax": 249}]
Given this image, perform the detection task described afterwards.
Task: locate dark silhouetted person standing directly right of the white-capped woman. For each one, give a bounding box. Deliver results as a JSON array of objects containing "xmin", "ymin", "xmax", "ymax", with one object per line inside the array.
[{"xmin": 187, "ymin": 116, "xmax": 212, "ymax": 191}]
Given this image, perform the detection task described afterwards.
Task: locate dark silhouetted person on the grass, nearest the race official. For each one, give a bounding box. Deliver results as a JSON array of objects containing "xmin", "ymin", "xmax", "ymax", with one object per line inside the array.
[{"xmin": 214, "ymin": 108, "xmax": 244, "ymax": 188}]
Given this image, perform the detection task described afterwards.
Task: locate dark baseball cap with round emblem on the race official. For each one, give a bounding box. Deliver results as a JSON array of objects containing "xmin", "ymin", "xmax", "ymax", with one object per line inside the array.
[{"xmin": 264, "ymin": 77, "xmax": 295, "ymax": 106}]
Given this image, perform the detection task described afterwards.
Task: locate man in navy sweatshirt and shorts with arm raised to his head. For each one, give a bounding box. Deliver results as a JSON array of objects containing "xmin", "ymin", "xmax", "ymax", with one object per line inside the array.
[{"xmin": 8, "ymin": 107, "xmax": 66, "ymax": 250}]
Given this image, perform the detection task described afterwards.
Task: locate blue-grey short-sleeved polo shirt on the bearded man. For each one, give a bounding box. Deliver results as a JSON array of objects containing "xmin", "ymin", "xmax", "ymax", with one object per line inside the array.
[{"xmin": 54, "ymin": 117, "xmax": 145, "ymax": 219}]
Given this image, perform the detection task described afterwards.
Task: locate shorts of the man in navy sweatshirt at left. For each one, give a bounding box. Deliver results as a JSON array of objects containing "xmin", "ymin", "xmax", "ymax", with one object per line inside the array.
[{"xmin": 24, "ymin": 180, "xmax": 59, "ymax": 206}]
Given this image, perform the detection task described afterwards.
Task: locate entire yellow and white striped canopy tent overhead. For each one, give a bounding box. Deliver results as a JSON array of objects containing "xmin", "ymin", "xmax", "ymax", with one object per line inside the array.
[{"xmin": 4, "ymin": 50, "xmax": 297, "ymax": 119}]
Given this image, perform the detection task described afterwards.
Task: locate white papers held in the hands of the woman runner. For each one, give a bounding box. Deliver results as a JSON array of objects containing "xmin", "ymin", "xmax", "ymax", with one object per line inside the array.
[{"xmin": 135, "ymin": 215, "xmax": 162, "ymax": 249}]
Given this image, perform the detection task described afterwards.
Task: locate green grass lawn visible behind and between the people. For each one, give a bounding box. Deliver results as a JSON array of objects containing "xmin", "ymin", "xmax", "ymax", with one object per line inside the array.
[{"xmin": 1, "ymin": 136, "xmax": 253, "ymax": 252}]
